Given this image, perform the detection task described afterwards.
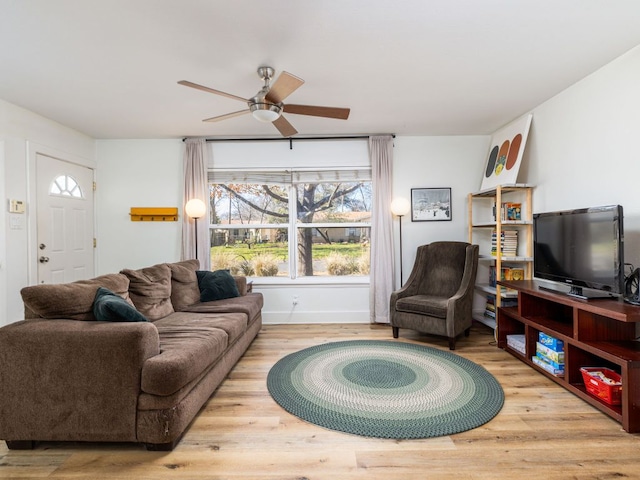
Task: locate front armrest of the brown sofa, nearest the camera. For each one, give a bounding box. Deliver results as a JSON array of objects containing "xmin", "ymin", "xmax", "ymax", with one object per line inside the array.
[{"xmin": 0, "ymin": 320, "xmax": 159, "ymax": 441}]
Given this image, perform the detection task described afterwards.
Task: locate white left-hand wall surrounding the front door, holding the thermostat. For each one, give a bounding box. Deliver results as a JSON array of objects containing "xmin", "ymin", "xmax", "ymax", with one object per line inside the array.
[{"xmin": 0, "ymin": 100, "xmax": 95, "ymax": 325}]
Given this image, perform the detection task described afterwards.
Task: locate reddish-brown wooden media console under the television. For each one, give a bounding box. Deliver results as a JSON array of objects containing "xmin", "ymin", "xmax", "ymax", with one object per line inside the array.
[{"xmin": 497, "ymin": 280, "xmax": 640, "ymax": 433}]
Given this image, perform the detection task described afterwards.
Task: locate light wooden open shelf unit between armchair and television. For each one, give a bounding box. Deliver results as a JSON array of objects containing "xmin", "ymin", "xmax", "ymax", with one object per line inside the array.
[{"xmin": 468, "ymin": 184, "xmax": 533, "ymax": 328}]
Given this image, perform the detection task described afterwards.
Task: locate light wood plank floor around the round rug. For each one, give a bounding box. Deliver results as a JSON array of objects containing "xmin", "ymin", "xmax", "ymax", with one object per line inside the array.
[{"xmin": 0, "ymin": 324, "xmax": 640, "ymax": 480}]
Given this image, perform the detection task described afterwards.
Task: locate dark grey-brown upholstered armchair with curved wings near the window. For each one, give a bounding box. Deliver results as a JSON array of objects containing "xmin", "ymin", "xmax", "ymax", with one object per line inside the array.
[{"xmin": 390, "ymin": 242, "xmax": 478, "ymax": 350}]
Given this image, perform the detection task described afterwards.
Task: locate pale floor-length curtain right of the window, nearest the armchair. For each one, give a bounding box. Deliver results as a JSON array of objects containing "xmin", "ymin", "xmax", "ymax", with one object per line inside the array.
[{"xmin": 369, "ymin": 135, "xmax": 394, "ymax": 323}]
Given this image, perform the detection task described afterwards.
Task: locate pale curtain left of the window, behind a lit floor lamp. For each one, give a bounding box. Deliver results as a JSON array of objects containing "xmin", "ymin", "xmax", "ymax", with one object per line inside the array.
[{"xmin": 182, "ymin": 139, "xmax": 211, "ymax": 270}]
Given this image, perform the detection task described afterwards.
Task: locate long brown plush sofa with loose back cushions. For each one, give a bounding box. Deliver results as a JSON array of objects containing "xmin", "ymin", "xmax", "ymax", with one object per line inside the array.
[{"xmin": 0, "ymin": 260, "xmax": 263, "ymax": 450}]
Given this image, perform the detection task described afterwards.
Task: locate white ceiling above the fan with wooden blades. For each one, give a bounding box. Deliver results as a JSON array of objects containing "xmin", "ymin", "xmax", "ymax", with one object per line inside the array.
[{"xmin": 0, "ymin": 0, "xmax": 640, "ymax": 138}]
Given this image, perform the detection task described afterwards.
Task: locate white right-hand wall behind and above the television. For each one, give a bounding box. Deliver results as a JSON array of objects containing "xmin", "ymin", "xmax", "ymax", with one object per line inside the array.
[{"xmin": 523, "ymin": 47, "xmax": 640, "ymax": 266}]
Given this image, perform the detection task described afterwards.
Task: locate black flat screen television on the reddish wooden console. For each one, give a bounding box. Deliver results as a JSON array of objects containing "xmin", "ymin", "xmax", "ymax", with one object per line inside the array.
[{"xmin": 533, "ymin": 205, "xmax": 624, "ymax": 298}]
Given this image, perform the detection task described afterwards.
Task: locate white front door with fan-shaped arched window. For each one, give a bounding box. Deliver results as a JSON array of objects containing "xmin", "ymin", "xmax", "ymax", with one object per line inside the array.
[{"xmin": 36, "ymin": 154, "xmax": 94, "ymax": 283}]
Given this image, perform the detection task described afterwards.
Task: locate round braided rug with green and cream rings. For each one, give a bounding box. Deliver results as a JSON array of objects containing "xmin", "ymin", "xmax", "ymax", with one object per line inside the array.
[{"xmin": 267, "ymin": 340, "xmax": 504, "ymax": 439}]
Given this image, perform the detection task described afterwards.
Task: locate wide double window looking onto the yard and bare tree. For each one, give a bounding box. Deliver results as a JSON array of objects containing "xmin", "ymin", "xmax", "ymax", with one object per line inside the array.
[{"xmin": 209, "ymin": 168, "xmax": 371, "ymax": 278}]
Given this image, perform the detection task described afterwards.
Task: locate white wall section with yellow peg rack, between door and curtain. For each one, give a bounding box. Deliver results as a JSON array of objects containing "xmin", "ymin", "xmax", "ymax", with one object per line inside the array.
[{"xmin": 96, "ymin": 140, "xmax": 183, "ymax": 274}]
